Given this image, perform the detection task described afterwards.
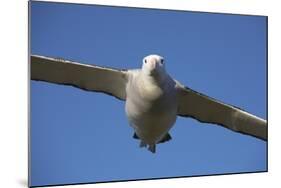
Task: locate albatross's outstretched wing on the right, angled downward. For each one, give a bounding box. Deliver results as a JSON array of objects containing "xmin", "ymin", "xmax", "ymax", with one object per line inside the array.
[{"xmin": 176, "ymin": 81, "xmax": 267, "ymax": 140}]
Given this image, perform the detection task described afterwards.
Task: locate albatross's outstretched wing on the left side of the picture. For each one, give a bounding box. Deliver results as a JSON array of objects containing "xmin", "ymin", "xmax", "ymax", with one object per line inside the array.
[{"xmin": 31, "ymin": 55, "xmax": 128, "ymax": 100}]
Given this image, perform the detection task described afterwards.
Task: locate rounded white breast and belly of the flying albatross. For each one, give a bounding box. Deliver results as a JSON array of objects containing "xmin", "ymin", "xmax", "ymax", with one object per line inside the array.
[{"xmin": 125, "ymin": 72, "xmax": 177, "ymax": 144}]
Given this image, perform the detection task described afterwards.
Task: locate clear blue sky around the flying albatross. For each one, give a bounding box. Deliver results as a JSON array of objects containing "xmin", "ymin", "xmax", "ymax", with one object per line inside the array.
[{"xmin": 31, "ymin": 2, "xmax": 267, "ymax": 186}]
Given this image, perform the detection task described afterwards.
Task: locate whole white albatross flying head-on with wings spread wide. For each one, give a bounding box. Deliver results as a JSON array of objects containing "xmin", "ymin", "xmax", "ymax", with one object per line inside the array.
[{"xmin": 31, "ymin": 55, "xmax": 267, "ymax": 153}]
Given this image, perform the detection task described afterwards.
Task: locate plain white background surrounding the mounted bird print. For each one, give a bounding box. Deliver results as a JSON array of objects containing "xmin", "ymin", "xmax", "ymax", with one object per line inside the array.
[{"xmin": 0, "ymin": 0, "xmax": 281, "ymax": 188}]
